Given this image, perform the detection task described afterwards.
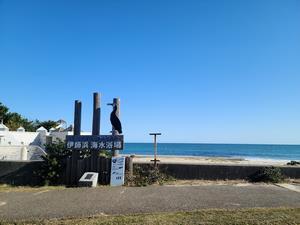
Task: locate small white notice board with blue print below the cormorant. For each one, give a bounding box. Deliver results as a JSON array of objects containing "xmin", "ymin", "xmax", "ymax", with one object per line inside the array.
[{"xmin": 110, "ymin": 157, "xmax": 125, "ymax": 186}]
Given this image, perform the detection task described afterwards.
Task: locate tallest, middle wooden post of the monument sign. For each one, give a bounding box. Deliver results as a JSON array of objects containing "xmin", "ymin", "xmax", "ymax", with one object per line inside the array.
[{"xmin": 91, "ymin": 93, "xmax": 101, "ymax": 172}]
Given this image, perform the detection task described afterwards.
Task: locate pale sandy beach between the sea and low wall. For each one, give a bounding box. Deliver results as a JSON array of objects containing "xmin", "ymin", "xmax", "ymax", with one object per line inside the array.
[{"xmin": 128, "ymin": 155, "xmax": 289, "ymax": 166}]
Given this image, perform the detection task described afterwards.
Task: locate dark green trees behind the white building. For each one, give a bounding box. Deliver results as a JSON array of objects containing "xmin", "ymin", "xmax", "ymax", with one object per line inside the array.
[{"xmin": 0, "ymin": 102, "xmax": 58, "ymax": 131}]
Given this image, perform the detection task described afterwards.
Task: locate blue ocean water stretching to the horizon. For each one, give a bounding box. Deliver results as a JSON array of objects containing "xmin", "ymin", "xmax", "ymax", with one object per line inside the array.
[{"xmin": 122, "ymin": 143, "xmax": 300, "ymax": 161}]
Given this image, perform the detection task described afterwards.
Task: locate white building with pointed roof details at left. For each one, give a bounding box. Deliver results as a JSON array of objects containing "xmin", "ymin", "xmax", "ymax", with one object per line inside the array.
[{"xmin": 0, "ymin": 121, "xmax": 79, "ymax": 160}]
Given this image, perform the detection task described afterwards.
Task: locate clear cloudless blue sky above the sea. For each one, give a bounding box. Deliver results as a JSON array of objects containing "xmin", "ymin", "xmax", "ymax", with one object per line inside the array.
[{"xmin": 0, "ymin": 0, "xmax": 300, "ymax": 144}]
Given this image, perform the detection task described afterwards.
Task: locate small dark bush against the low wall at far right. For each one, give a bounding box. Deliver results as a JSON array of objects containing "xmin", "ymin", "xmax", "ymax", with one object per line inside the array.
[{"xmin": 249, "ymin": 166, "xmax": 284, "ymax": 183}]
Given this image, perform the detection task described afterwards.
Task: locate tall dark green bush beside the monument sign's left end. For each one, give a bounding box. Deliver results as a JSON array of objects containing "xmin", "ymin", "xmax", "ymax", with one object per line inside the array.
[{"xmin": 38, "ymin": 142, "xmax": 71, "ymax": 185}]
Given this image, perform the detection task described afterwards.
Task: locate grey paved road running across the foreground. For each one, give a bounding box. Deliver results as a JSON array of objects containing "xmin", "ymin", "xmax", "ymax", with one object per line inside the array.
[{"xmin": 0, "ymin": 185, "xmax": 300, "ymax": 219}]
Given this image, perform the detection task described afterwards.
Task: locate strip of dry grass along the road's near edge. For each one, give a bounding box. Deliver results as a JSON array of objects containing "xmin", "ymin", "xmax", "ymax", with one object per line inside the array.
[{"xmin": 0, "ymin": 208, "xmax": 300, "ymax": 225}]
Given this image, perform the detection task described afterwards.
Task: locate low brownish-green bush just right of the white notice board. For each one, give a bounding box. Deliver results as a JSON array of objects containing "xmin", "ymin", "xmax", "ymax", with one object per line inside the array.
[{"xmin": 125, "ymin": 165, "xmax": 174, "ymax": 187}]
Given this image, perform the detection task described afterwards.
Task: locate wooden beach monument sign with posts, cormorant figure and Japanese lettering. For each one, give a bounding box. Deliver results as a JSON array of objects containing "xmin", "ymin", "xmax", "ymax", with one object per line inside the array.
[{"xmin": 66, "ymin": 93, "xmax": 125, "ymax": 186}]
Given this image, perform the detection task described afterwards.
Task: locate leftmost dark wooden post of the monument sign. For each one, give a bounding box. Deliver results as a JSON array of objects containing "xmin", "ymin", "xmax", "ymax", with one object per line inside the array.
[{"xmin": 70, "ymin": 100, "xmax": 82, "ymax": 185}]
